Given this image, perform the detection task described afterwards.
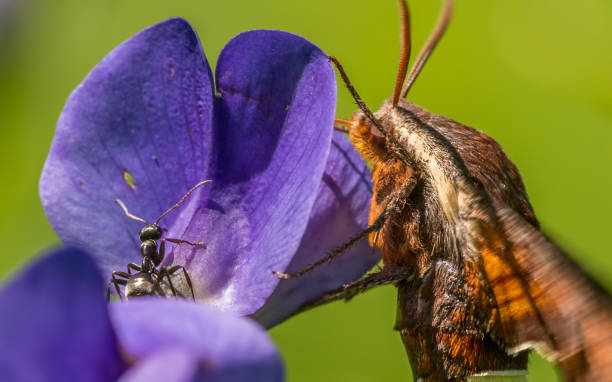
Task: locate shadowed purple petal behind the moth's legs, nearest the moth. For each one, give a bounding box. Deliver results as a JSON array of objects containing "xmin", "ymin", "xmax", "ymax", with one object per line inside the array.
[{"xmin": 253, "ymin": 132, "xmax": 380, "ymax": 328}]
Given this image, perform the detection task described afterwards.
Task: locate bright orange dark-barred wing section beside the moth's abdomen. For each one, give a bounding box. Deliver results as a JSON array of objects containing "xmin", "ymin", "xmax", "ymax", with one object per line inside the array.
[{"xmin": 460, "ymin": 208, "xmax": 556, "ymax": 359}]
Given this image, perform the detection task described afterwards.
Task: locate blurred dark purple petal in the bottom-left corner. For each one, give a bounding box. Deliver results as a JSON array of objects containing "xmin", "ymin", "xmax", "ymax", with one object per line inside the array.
[{"xmin": 0, "ymin": 249, "xmax": 123, "ymax": 382}]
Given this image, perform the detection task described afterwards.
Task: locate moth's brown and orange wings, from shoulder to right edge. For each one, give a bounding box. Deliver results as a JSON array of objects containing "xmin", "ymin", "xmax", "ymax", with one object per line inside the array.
[{"xmin": 403, "ymin": 103, "xmax": 612, "ymax": 380}]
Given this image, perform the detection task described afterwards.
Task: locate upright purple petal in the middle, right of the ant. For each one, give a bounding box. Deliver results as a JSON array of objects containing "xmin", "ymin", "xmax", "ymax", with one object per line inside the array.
[{"xmin": 171, "ymin": 31, "xmax": 336, "ymax": 314}]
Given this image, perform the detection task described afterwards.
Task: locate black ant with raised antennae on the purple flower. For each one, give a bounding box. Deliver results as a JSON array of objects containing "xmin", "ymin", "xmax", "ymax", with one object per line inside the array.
[{"xmin": 106, "ymin": 180, "xmax": 211, "ymax": 301}]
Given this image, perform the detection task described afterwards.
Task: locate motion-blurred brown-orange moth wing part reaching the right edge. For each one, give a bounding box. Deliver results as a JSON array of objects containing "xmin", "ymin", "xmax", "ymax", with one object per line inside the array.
[{"xmin": 497, "ymin": 208, "xmax": 612, "ymax": 381}]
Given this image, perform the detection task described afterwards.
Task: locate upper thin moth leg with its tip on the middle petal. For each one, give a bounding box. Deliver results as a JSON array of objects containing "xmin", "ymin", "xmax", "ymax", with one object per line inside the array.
[{"xmin": 272, "ymin": 175, "xmax": 417, "ymax": 279}]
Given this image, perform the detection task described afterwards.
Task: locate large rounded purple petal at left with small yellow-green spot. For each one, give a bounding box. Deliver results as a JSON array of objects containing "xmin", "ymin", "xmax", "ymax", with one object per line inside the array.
[{"xmin": 40, "ymin": 19, "xmax": 213, "ymax": 275}]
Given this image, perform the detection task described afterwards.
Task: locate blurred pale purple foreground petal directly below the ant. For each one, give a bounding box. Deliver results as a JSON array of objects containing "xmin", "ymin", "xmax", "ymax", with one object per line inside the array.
[{"xmin": 111, "ymin": 298, "xmax": 284, "ymax": 382}]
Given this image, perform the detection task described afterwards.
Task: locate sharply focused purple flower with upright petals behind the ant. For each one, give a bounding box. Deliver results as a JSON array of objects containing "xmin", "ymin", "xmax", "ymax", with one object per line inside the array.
[{"xmin": 40, "ymin": 19, "xmax": 378, "ymax": 326}]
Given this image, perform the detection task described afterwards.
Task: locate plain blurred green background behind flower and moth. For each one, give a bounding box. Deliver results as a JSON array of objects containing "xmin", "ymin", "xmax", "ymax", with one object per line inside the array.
[{"xmin": 0, "ymin": 0, "xmax": 612, "ymax": 382}]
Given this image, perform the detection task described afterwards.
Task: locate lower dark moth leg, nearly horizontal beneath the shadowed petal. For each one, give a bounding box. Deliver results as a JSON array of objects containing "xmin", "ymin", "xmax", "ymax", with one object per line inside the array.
[{"xmin": 293, "ymin": 268, "xmax": 414, "ymax": 315}]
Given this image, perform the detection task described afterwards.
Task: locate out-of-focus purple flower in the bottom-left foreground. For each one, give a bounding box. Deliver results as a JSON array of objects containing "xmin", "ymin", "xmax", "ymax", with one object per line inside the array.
[{"xmin": 0, "ymin": 249, "xmax": 283, "ymax": 382}]
